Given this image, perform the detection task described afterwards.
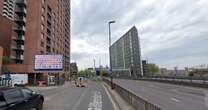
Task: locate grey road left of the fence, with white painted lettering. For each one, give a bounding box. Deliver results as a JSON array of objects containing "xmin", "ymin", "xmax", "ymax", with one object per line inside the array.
[{"xmin": 30, "ymin": 81, "xmax": 114, "ymax": 110}]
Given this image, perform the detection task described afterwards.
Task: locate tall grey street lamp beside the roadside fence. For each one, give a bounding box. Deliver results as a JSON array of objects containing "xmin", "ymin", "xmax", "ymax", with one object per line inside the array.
[{"xmin": 108, "ymin": 21, "xmax": 116, "ymax": 89}]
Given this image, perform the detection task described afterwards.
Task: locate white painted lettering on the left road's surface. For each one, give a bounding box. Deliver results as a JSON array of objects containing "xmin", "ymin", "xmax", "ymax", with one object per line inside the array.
[{"xmin": 88, "ymin": 91, "xmax": 102, "ymax": 110}]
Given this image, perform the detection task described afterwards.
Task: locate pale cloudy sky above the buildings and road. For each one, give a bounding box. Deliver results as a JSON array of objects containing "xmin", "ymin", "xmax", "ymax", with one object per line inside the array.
[{"xmin": 71, "ymin": 0, "xmax": 208, "ymax": 69}]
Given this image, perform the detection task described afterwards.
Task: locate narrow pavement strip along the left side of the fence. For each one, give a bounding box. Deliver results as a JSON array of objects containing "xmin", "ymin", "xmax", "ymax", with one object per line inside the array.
[{"xmin": 103, "ymin": 82, "xmax": 136, "ymax": 110}]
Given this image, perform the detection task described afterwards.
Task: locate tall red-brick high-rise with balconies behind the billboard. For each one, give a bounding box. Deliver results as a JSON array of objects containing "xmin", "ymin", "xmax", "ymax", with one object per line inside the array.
[{"xmin": 0, "ymin": 0, "xmax": 70, "ymax": 84}]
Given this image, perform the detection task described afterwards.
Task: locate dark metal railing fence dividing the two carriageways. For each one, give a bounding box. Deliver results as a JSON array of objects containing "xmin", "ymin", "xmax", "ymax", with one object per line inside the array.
[{"xmin": 103, "ymin": 78, "xmax": 162, "ymax": 110}]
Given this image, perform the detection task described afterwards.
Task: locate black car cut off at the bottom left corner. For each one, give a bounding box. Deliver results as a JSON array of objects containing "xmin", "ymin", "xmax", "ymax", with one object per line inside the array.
[{"xmin": 0, "ymin": 87, "xmax": 44, "ymax": 110}]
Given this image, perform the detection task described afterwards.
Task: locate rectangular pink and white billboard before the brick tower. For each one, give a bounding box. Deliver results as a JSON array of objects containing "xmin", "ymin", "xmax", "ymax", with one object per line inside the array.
[{"xmin": 34, "ymin": 55, "xmax": 63, "ymax": 71}]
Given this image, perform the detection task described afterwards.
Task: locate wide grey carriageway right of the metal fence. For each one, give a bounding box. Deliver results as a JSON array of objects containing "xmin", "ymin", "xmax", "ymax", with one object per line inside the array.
[{"xmin": 114, "ymin": 79, "xmax": 208, "ymax": 110}]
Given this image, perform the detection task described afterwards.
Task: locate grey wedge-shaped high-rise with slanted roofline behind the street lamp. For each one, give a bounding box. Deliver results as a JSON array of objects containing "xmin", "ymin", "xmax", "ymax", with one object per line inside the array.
[{"xmin": 110, "ymin": 26, "xmax": 142, "ymax": 77}]
